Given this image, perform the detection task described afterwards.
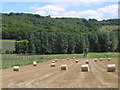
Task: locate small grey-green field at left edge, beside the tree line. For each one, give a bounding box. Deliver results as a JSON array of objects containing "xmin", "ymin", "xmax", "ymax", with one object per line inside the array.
[{"xmin": 0, "ymin": 39, "xmax": 15, "ymax": 51}]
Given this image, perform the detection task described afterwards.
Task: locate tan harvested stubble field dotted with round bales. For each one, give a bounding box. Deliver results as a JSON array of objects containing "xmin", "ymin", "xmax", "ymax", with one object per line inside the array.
[{"xmin": 2, "ymin": 58, "xmax": 118, "ymax": 88}]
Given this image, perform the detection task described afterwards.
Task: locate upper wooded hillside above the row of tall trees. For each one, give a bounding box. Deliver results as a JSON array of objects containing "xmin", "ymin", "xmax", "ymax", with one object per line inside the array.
[{"xmin": 2, "ymin": 13, "xmax": 118, "ymax": 39}]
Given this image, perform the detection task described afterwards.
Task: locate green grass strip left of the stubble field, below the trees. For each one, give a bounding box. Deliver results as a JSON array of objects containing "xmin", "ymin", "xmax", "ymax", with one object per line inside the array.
[{"xmin": 2, "ymin": 54, "xmax": 83, "ymax": 68}]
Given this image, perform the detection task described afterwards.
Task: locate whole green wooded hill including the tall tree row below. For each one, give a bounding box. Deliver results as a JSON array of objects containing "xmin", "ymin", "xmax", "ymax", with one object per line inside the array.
[{"xmin": 2, "ymin": 13, "xmax": 119, "ymax": 54}]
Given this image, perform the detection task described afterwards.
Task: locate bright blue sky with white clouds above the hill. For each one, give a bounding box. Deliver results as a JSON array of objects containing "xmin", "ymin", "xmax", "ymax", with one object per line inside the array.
[{"xmin": 2, "ymin": 0, "xmax": 118, "ymax": 20}]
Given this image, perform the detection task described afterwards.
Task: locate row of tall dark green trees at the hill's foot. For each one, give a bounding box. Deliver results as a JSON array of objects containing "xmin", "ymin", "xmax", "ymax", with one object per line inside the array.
[{"xmin": 16, "ymin": 31, "xmax": 118, "ymax": 54}]
